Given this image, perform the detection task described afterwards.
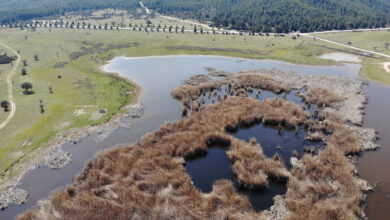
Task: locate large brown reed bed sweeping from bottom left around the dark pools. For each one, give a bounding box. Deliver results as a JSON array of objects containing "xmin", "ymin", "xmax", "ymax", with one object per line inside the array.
[{"xmin": 19, "ymin": 97, "xmax": 307, "ymax": 219}]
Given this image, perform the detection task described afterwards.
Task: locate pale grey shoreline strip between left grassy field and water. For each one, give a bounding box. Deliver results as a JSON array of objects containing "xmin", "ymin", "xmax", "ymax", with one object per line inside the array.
[{"xmin": 0, "ymin": 66, "xmax": 143, "ymax": 210}]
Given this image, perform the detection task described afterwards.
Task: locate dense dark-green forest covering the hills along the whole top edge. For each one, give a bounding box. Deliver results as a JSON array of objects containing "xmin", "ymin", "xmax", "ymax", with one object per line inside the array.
[{"xmin": 0, "ymin": 0, "xmax": 390, "ymax": 33}]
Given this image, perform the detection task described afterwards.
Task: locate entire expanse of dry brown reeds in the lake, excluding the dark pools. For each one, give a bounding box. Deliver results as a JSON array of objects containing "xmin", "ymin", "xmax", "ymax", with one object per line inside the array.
[{"xmin": 19, "ymin": 71, "xmax": 372, "ymax": 219}]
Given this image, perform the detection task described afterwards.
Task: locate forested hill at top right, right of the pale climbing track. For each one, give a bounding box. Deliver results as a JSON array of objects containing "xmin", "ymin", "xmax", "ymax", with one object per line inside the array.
[{"xmin": 145, "ymin": 0, "xmax": 390, "ymax": 32}]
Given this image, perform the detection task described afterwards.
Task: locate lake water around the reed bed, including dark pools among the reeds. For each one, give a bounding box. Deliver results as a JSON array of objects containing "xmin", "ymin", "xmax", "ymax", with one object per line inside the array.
[{"xmin": 0, "ymin": 56, "xmax": 390, "ymax": 219}]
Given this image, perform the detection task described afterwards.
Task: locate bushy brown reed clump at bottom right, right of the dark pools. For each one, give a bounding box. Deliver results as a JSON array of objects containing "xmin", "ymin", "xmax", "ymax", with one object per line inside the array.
[{"xmin": 285, "ymin": 145, "xmax": 364, "ymax": 220}]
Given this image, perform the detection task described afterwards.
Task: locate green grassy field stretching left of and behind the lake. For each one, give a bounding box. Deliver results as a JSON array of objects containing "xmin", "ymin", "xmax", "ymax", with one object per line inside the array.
[{"xmin": 0, "ymin": 23, "xmax": 354, "ymax": 184}]
